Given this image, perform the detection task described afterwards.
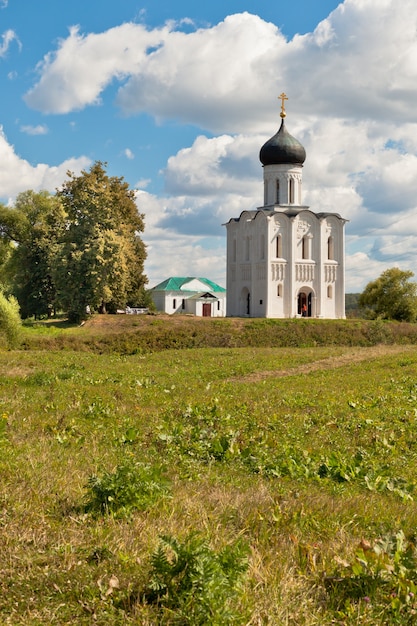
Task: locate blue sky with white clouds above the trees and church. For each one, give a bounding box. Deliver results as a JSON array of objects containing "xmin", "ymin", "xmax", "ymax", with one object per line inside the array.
[{"xmin": 0, "ymin": 0, "xmax": 417, "ymax": 293}]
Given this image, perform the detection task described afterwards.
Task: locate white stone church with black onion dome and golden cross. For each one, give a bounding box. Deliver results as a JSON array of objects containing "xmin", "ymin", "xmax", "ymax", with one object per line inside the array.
[{"xmin": 225, "ymin": 93, "xmax": 347, "ymax": 319}]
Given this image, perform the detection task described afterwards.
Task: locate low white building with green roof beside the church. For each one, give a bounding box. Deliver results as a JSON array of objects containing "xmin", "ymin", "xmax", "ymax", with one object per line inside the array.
[{"xmin": 150, "ymin": 276, "xmax": 226, "ymax": 317}]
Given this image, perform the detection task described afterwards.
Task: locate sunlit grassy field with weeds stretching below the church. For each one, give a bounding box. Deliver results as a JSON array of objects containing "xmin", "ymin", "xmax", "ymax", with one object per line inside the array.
[{"xmin": 0, "ymin": 316, "xmax": 417, "ymax": 626}]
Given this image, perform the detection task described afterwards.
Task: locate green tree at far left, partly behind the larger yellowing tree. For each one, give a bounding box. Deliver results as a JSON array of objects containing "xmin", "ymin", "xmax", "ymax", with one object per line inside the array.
[{"xmin": 0, "ymin": 191, "xmax": 65, "ymax": 318}]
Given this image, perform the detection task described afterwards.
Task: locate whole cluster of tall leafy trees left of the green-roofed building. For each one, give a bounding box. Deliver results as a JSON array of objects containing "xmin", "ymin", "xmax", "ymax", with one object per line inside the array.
[{"xmin": 0, "ymin": 161, "xmax": 149, "ymax": 322}]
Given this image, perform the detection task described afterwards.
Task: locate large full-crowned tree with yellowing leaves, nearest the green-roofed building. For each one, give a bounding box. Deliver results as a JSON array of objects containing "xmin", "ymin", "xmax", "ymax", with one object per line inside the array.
[{"xmin": 55, "ymin": 161, "xmax": 147, "ymax": 321}]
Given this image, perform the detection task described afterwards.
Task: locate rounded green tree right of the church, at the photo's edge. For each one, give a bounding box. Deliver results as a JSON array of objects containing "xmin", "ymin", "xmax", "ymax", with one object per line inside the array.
[{"xmin": 359, "ymin": 267, "xmax": 417, "ymax": 322}]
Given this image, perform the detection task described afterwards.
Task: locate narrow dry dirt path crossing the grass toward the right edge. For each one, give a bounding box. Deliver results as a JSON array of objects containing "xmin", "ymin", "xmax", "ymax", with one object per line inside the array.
[{"xmin": 229, "ymin": 345, "xmax": 417, "ymax": 382}]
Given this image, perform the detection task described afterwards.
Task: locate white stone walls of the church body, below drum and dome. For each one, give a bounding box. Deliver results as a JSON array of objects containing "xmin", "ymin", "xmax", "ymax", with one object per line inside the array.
[{"xmin": 226, "ymin": 207, "xmax": 345, "ymax": 319}]
